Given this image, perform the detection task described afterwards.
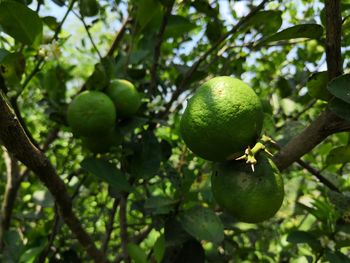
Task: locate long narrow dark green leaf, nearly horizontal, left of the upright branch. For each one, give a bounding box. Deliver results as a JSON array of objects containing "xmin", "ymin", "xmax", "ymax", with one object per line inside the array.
[{"xmin": 258, "ymin": 24, "xmax": 323, "ymax": 46}]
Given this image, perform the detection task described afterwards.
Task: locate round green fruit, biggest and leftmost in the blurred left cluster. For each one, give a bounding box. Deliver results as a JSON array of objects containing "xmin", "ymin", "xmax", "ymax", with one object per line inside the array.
[{"xmin": 67, "ymin": 91, "xmax": 116, "ymax": 136}]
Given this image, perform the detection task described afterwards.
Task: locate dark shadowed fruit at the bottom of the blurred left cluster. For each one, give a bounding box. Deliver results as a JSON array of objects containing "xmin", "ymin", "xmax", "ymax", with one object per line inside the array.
[{"xmin": 82, "ymin": 129, "xmax": 123, "ymax": 153}]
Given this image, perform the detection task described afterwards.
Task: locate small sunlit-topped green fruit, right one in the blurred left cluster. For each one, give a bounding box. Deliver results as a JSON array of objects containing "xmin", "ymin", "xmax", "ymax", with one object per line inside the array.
[{"xmin": 106, "ymin": 79, "xmax": 141, "ymax": 117}]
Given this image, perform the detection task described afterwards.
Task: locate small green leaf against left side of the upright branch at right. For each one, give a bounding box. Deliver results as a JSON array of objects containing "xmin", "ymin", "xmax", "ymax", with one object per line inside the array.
[{"xmin": 306, "ymin": 71, "xmax": 332, "ymax": 101}]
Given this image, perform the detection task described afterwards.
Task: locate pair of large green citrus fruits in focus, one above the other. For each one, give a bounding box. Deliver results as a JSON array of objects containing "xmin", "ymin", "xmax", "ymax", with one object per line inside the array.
[{"xmin": 180, "ymin": 76, "xmax": 284, "ymax": 223}]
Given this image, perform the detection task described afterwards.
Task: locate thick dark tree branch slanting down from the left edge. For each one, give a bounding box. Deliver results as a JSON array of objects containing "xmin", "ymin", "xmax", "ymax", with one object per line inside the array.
[{"xmin": 0, "ymin": 92, "xmax": 105, "ymax": 262}]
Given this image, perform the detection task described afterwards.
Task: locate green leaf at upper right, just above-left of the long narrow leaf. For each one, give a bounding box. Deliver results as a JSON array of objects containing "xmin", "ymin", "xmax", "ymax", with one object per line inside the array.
[{"xmin": 243, "ymin": 10, "xmax": 282, "ymax": 35}]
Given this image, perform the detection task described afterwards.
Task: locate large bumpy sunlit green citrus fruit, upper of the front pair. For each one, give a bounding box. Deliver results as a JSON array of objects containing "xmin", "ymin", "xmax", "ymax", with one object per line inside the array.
[{"xmin": 180, "ymin": 76, "xmax": 264, "ymax": 161}]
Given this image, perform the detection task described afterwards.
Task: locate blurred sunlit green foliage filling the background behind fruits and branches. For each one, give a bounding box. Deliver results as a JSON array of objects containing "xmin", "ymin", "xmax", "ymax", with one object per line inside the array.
[{"xmin": 0, "ymin": 0, "xmax": 350, "ymax": 263}]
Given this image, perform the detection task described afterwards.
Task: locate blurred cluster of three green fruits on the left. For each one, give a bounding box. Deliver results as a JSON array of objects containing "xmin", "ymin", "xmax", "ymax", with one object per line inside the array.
[{"xmin": 67, "ymin": 79, "xmax": 141, "ymax": 153}]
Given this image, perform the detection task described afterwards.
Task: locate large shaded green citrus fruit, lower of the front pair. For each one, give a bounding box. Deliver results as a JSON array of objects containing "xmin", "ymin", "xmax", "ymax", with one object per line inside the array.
[{"xmin": 211, "ymin": 155, "xmax": 284, "ymax": 223}]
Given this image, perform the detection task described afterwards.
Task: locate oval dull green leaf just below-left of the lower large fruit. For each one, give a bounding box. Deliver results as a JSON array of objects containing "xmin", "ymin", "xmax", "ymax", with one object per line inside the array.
[{"xmin": 180, "ymin": 206, "xmax": 224, "ymax": 243}]
